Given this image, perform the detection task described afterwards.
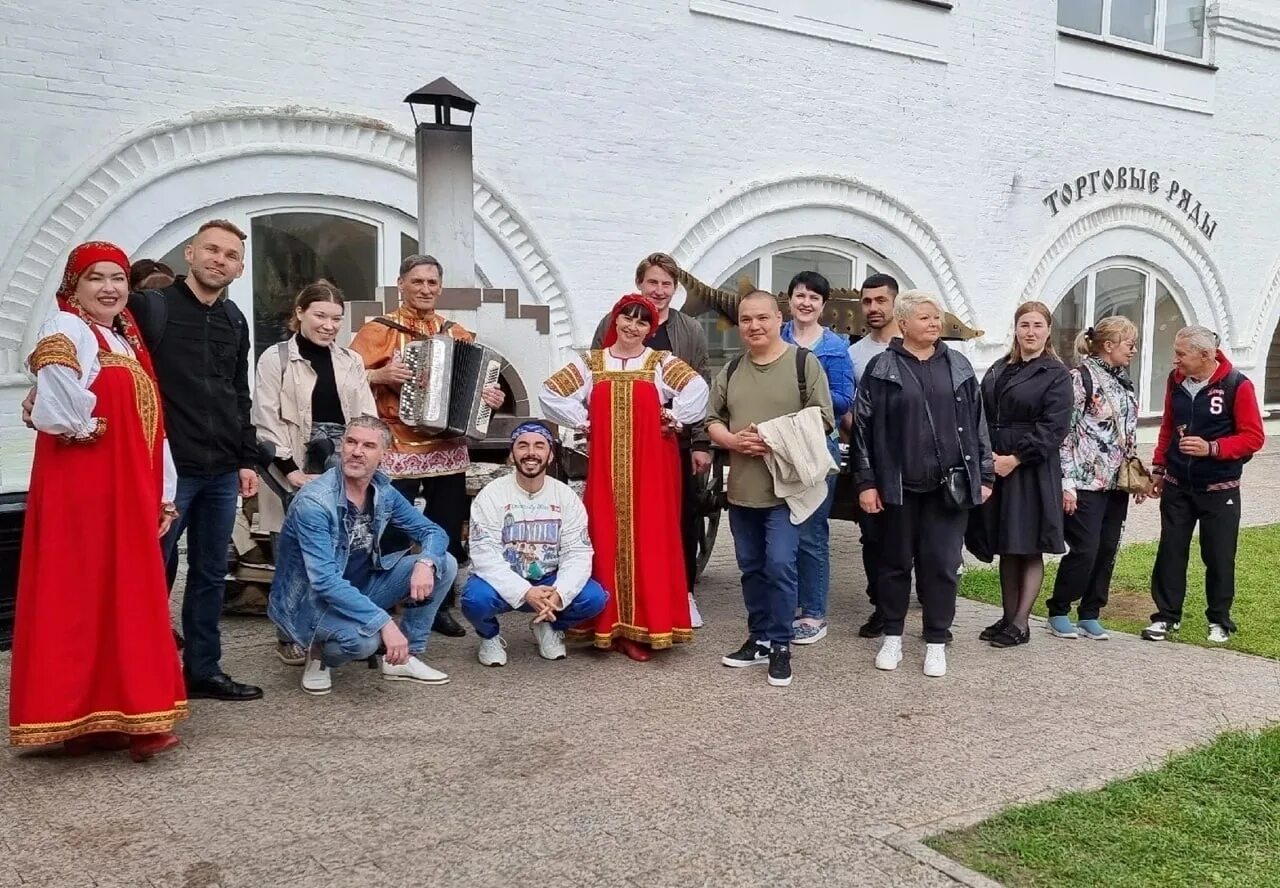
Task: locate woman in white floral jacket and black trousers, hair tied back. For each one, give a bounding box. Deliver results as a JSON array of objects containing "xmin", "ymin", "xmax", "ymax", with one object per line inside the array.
[{"xmin": 1048, "ymin": 316, "xmax": 1143, "ymax": 641}]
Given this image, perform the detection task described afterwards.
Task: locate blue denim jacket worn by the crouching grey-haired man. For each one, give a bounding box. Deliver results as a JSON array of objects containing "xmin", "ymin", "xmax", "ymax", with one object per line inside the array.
[{"xmin": 268, "ymin": 468, "xmax": 449, "ymax": 645}]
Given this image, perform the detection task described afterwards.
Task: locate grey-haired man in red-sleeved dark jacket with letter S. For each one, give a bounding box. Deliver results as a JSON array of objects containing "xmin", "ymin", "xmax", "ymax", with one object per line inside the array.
[{"xmin": 1142, "ymin": 326, "xmax": 1266, "ymax": 644}]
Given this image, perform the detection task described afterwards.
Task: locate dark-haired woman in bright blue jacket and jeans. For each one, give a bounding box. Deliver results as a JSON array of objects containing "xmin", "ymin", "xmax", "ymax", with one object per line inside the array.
[{"xmin": 782, "ymin": 271, "xmax": 854, "ymax": 645}]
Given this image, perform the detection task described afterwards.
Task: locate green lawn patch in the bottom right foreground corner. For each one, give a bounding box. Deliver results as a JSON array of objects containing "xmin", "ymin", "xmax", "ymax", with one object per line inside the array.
[{"xmin": 925, "ymin": 729, "xmax": 1280, "ymax": 888}]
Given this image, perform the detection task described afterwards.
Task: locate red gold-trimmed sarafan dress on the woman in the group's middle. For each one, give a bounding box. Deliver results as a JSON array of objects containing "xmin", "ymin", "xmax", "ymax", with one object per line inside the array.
[{"xmin": 567, "ymin": 351, "xmax": 694, "ymax": 649}]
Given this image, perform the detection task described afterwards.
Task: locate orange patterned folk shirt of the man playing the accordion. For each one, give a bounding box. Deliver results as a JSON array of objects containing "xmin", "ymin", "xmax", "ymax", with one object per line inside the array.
[{"xmin": 351, "ymin": 306, "xmax": 475, "ymax": 479}]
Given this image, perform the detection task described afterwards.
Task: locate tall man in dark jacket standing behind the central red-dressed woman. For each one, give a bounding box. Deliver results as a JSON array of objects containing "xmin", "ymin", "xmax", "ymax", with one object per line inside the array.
[{"xmin": 591, "ymin": 253, "xmax": 712, "ymax": 628}]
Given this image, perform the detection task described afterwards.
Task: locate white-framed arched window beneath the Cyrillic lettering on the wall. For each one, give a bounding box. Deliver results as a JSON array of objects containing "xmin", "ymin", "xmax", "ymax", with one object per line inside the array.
[{"xmin": 1053, "ymin": 258, "xmax": 1187, "ymax": 416}]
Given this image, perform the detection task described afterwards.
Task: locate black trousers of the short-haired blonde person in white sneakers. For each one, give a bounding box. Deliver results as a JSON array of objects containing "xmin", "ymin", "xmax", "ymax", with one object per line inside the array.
[{"xmin": 877, "ymin": 488, "xmax": 969, "ymax": 645}]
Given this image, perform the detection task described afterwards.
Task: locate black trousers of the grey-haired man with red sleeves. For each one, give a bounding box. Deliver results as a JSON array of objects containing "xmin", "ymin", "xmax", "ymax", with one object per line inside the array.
[{"xmin": 1151, "ymin": 482, "xmax": 1240, "ymax": 632}]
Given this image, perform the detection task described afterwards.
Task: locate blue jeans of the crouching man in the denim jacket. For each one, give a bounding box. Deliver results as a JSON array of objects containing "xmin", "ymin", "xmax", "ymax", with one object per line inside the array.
[{"xmin": 312, "ymin": 553, "xmax": 458, "ymax": 668}]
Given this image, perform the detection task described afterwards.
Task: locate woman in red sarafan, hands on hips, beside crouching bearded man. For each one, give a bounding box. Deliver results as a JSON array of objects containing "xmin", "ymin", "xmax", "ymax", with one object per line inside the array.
[{"xmin": 539, "ymin": 293, "xmax": 708, "ymax": 660}]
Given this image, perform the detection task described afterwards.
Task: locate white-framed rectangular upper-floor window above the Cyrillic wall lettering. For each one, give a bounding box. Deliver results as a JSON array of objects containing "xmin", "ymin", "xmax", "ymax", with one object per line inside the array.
[{"xmin": 1057, "ymin": 0, "xmax": 1208, "ymax": 60}]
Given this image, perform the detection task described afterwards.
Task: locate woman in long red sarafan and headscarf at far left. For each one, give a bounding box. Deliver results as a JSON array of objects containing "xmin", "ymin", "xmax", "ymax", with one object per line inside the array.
[{"xmin": 9, "ymin": 242, "xmax": 187, "ymax": 761}]
